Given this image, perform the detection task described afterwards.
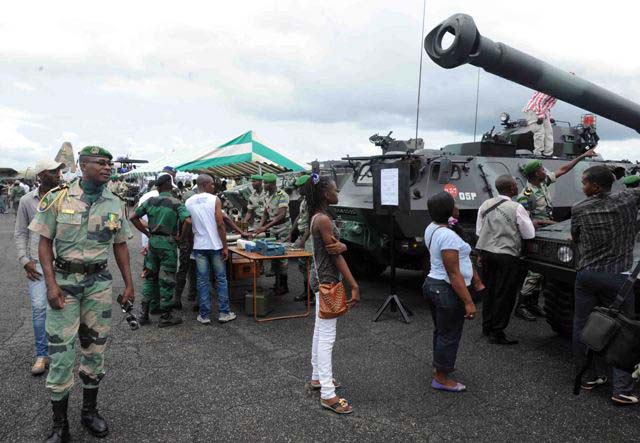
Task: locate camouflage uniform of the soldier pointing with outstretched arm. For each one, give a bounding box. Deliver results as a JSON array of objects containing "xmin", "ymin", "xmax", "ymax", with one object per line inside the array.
[{"xmin": 516, "ymin": 172, "xmax": 556, "ymax": 308}]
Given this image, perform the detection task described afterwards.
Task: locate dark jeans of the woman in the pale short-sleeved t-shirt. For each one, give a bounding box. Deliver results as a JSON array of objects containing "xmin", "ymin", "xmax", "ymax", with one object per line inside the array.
[{"xmin": 422, "ymin": 277, "xmax": 465, "ymax": 373}]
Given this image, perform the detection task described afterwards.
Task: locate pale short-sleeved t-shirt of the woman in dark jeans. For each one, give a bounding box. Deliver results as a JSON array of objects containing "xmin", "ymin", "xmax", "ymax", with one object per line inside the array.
[{"xmin": 424, "ymin": 223, "xmax": 473, "ymax": 286}]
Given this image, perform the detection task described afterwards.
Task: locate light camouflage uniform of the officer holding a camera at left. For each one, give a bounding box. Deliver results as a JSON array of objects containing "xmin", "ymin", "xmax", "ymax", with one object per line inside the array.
[{"xmin": 29, "ymin": 181, "xmax": 131, "ymax": 401}]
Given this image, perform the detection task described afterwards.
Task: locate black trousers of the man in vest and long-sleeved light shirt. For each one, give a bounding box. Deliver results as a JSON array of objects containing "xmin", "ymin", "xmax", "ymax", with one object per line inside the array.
[{"xmin": 480, "ymin": 251, "xmax": 524, "ymax": 336}]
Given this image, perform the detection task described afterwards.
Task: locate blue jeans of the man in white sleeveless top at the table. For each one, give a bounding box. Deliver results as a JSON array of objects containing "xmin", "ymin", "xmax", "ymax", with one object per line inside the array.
[{"xmin": 193, "ymin": 249, "xmax": 229, "ymax": 318}]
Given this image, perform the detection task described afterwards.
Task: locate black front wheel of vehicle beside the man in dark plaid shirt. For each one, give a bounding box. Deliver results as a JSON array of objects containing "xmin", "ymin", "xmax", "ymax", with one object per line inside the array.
[{"xmin": 542, "ymin": 280, "xmax": 574, "ymax": 337}]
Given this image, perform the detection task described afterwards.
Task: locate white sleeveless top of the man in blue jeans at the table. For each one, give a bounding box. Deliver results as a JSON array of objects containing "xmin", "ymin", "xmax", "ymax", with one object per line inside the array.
[{"xmin": 185, "ymin": 192, "xmax": 222, "ymax": 251}]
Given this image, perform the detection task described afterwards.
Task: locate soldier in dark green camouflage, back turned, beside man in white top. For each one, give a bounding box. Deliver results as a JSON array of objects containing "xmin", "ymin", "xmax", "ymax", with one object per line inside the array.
[{"xmin": 131, "ymin": 174, "xmax": 189, "ymax": 328}]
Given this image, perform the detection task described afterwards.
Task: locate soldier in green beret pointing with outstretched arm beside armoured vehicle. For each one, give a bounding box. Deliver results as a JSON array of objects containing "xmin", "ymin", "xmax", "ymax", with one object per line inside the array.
[{"xmin": 515, "ymin": 148, "xmax": 596, "ymax": 321}]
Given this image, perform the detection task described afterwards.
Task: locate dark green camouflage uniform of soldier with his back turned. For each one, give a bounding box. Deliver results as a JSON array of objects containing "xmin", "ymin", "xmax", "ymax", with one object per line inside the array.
[{"xmin": 136, "ymin": 192, "xmax": 189, "ymax": 312}]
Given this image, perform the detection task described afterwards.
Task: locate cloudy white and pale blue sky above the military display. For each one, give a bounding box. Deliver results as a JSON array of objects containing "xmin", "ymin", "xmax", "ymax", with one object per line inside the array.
[{"xmin": 0, "ymin": 0, "xmax": 640, "ymax": 169}]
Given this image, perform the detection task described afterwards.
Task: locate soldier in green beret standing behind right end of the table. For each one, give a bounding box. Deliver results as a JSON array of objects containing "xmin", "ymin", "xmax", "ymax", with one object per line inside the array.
[{"xmin": 255, "ymin": 173, "xmax": 291, "ymax": 295}]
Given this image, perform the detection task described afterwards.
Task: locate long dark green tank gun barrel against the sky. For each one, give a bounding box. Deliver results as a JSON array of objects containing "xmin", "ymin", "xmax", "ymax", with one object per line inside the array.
[{"xmin": 424, "ymin": 14, "xmax": 640, "ymax": 132}]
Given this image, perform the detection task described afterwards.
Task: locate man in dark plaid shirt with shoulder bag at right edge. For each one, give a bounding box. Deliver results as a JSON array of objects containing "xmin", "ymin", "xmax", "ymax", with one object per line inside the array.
[{"xmin": 571, "ymin": 166, "xmax": 640, "ymax": 405}]
